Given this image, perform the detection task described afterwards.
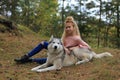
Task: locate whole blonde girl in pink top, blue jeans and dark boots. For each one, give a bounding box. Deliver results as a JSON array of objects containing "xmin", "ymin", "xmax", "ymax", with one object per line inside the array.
[{"xmin": 14, "ymin": 16, "xmax": 91, "ymax": 64}]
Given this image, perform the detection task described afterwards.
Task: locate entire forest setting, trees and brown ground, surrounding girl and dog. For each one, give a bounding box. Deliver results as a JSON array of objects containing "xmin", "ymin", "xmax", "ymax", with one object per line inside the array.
[{"xmin": 0, "ymin": 0, "xmax": 120, "ymax": 80}]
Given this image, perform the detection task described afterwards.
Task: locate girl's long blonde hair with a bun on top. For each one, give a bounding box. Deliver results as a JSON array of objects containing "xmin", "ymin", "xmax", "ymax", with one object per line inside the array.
[{"xmin": 61, "ymin": 16, "xmax": 80, "ymax": 41}]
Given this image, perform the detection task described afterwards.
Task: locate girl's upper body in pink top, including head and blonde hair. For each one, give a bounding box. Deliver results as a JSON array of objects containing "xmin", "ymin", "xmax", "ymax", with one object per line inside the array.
[{"xmin": 62, "ymin": 16, "xmax": 91, "ymax": 54}]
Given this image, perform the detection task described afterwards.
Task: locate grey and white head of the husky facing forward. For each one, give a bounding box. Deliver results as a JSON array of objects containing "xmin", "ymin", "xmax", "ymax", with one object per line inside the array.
[{"xmin": 48, "ymin": 36, "xmax": 63, "ymax": 54}]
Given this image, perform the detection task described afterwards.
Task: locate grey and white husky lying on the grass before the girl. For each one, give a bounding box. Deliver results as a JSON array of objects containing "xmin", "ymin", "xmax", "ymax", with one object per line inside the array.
[{"xmin": 31, "ymin": 36, "xmax": 112, "ymax": 72}]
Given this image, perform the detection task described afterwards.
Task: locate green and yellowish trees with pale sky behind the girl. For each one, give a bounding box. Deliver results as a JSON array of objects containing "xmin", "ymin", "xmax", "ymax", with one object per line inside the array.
[{"xmin": 0, "ymin": 0, "xmax": 120, "ymax": 48}]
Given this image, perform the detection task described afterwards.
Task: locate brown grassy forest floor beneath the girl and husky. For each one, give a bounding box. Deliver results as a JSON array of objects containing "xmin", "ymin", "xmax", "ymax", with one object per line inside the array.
[{"xmin": 0, "ymin": 30, "xmax": 120, "ymax": 80}]
